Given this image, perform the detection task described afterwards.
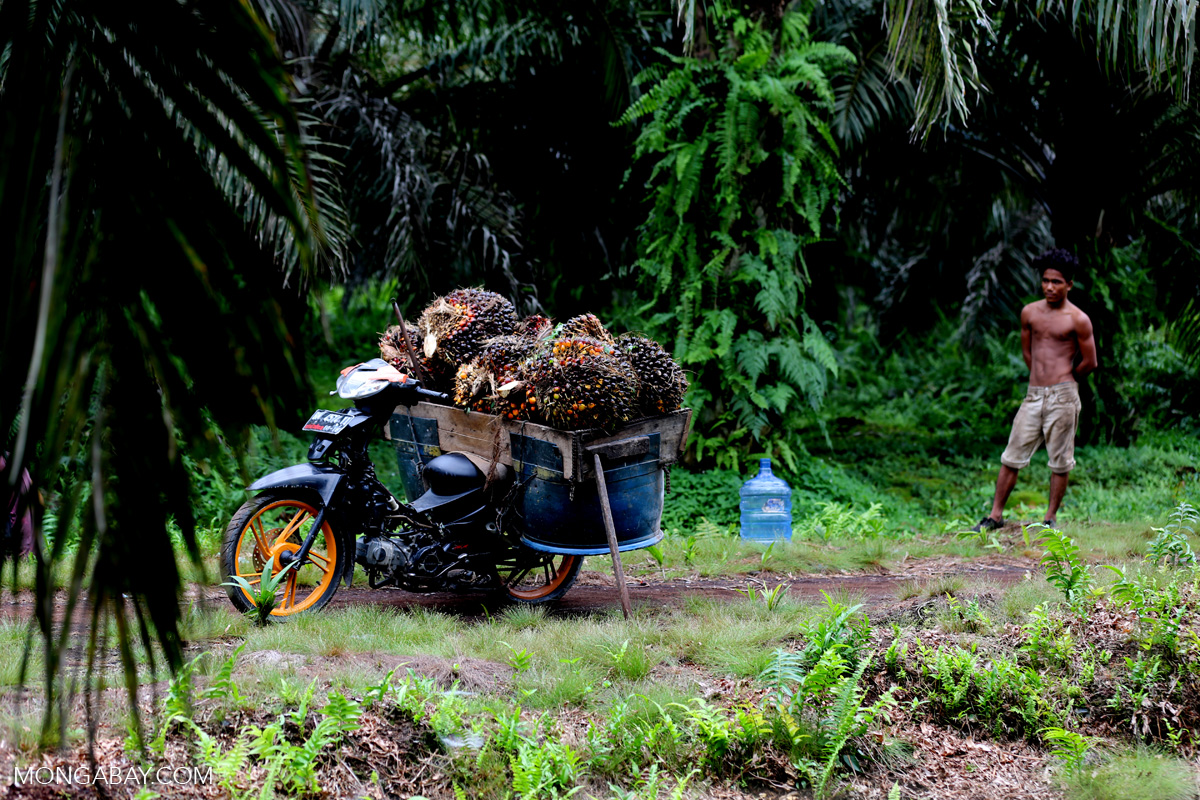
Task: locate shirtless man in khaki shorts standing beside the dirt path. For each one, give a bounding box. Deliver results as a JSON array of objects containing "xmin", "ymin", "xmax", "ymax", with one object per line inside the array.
[{"xmin": 971, "ymin": 249, "xmax": 1096, "ymax": 533}]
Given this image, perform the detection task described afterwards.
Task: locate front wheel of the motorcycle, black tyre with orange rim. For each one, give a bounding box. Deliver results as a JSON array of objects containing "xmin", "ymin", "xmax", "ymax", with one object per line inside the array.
[{"xmin": 221, "ymin": 492, "xmax": 347, "ymax": 616}]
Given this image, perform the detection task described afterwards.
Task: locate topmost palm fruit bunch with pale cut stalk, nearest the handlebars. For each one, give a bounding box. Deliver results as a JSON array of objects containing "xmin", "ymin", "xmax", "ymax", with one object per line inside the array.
[{"xmin": 416, "ymin": 289, "xmax": 517, "ymax": 368}]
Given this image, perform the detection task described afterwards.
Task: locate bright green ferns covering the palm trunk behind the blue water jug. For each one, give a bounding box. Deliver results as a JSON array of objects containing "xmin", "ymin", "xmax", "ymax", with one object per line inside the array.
[{"xmin": 620, "ymin": 5, "xmax": 850, "ymax": 455}]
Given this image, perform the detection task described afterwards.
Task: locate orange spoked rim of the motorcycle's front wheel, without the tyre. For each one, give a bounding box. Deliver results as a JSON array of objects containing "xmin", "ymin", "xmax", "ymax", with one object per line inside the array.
[{"xmin": 234, "ymin": 500, "xmax": 337, "ymax": 616}]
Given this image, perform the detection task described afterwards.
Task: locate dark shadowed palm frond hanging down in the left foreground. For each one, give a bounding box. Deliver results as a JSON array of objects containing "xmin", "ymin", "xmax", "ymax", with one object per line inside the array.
[{"xmin": 0, "ymin": 0, "xmax": 318, "ymax": 748}]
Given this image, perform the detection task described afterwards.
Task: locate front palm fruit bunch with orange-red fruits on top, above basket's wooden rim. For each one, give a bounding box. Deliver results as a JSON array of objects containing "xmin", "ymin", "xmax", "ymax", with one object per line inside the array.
[{"xmin": 520, "ymin": 337, "xmax": 637, "ymax": 431}]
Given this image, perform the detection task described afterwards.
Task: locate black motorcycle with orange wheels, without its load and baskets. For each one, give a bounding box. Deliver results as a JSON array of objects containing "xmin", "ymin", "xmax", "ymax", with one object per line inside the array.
[{"xmin": 221, "ymin": 359, "xmax": 583, "ymax": 616}]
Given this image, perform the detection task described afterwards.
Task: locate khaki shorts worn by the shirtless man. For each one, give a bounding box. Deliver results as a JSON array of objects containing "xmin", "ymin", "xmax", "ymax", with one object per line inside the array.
[{"xmin": 1000, "ymin": 380, "xmax": 1079, "ymax": 475}]
